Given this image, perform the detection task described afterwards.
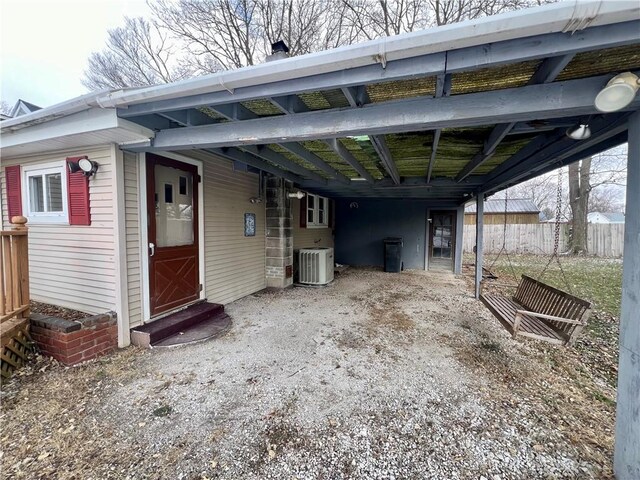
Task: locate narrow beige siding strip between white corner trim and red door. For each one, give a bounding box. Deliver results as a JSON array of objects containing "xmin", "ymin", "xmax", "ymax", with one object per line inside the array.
[{"xmin": 124, "ymin": 152, "xmax": 142, "ymax": 327}]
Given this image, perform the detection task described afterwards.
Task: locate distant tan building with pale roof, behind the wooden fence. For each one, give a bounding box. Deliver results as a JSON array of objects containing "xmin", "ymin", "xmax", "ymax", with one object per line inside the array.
[{"xmin": 464, "ymin": 198, "xmax": 540, "ymax": 225}]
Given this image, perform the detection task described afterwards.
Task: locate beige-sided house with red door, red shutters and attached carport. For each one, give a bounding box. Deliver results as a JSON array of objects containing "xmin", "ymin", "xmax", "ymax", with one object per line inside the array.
[{"xmin": 0, "ymin": 0, "xmax": 640, "ymax": 471}]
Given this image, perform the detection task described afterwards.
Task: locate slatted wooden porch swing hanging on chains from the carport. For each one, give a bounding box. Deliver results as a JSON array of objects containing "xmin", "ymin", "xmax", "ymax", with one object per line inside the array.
[{"xmin": 480, "ymin": 171, "xmax": 591, "ymax": 346}]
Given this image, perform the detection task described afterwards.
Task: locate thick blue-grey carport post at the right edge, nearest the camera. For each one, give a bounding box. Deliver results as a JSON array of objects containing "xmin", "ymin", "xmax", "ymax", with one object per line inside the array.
[{"xmin": 613, "ymin": 111, "xmax": 640, "ymax": 480}]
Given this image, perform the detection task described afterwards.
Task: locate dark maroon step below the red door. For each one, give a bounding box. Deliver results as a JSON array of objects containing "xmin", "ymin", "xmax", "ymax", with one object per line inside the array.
[{"xmin": 131, "ymin": 302, "xmax": 224, "ymax": 347}]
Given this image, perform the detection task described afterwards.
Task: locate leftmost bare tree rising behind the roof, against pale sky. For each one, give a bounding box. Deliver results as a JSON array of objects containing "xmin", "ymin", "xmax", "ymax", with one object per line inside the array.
[{"xmin": 83, "ymin": 17, "xmax": 193, "ymax": 90}]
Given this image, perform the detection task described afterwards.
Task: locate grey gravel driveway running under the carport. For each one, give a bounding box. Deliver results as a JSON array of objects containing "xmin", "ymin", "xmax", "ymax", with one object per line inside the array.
[{"xmin": 3, "ymin": 269, "xmax": 611, "ymax": 480}]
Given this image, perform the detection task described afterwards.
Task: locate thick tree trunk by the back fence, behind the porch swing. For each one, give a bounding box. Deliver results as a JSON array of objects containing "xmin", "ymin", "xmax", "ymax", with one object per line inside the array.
[{"xmin": 569, "ymin": 157, "xmax": 591, "ymax": 254}]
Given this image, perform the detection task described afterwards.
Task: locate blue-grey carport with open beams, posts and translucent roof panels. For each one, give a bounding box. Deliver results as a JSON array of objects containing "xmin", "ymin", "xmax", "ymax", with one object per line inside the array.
[{"xmin": 100, "ymin": 1, "xmax": 640, "ymax": 478}]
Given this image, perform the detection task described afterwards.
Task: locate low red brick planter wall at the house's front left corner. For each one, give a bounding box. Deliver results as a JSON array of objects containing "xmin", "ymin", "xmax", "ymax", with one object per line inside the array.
[{"xmin": 30, "ymin": 312, "xmax": 118, "ymax": 365}]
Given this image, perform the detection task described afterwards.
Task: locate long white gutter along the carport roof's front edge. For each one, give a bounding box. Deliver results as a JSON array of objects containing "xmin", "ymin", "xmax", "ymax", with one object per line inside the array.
[{"xmin": 97, "ymin": 0, "xmax": 640, "ymax": 108}]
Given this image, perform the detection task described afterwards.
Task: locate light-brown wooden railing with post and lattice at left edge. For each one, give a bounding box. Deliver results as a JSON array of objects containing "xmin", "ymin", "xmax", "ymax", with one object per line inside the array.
[{"xmin": 0, "ymin": 217, "xmax": 29, "ymax": 377}]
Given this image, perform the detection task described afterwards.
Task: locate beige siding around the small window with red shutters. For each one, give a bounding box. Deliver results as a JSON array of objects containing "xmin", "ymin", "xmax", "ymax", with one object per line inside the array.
[{"xmin": 0, "ymin": 146, "xmax": 116, "ymax": 313}]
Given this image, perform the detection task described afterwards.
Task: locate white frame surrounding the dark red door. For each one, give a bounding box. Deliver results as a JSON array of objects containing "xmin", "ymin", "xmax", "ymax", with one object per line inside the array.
[{"xmin": 138, "ymin": 152, "xmax": 207, "ymax": 323}]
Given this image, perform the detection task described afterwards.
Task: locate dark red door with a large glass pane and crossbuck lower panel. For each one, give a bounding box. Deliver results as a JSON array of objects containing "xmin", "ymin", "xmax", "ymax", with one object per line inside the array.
[{"xmin": 147, "ymin": 154, "xmax": 200, "ymax": 316}]
